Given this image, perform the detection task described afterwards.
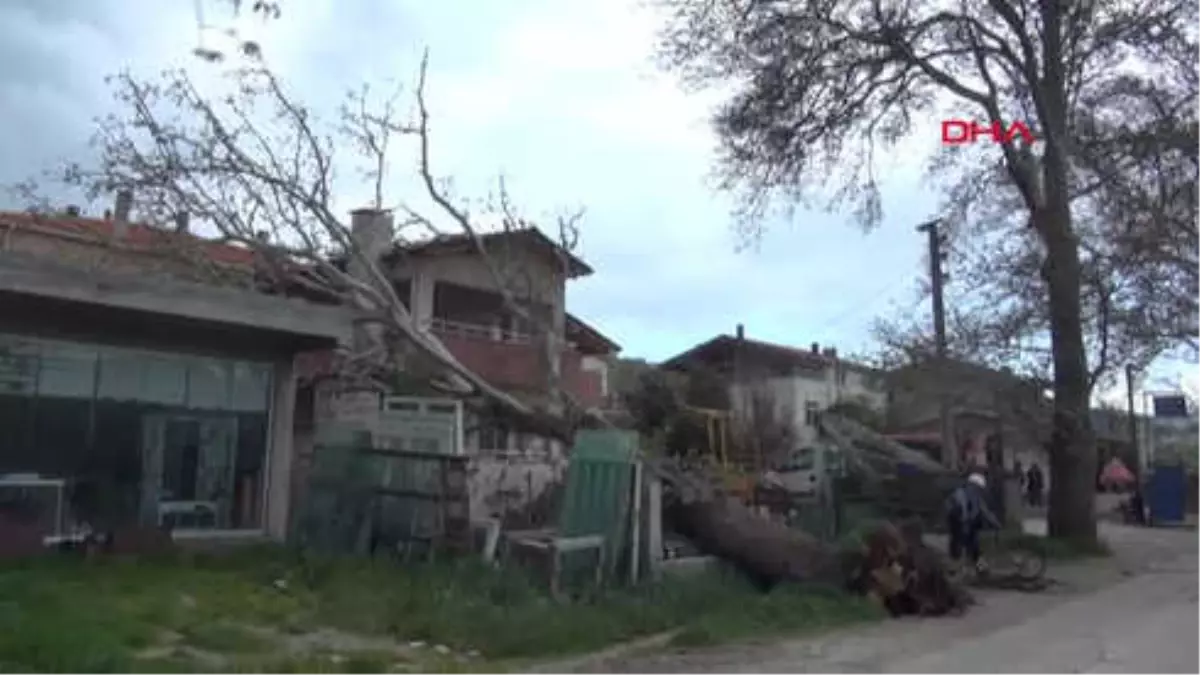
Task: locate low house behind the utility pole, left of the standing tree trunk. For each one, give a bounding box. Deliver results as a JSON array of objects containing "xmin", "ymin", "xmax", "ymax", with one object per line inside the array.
[{"xmin": 886, "ymin": 359, "xmax": 1049, "ymax": 467}]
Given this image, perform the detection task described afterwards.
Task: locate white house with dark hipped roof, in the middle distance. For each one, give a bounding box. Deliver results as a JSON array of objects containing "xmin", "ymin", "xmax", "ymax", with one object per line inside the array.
[{"xmin": 660, "ymin": 325, "xmax": 886, "ymax": 444}]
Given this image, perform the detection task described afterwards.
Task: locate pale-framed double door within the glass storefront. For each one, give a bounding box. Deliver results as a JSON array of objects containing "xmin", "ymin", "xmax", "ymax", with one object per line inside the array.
[{"xmin": 140, "ymin": 413, "xmax": 238, "ymax": 528}]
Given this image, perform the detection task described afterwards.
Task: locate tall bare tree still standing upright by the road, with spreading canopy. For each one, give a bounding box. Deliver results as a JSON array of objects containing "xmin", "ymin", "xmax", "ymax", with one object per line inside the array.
[{"xmin": 659, "ymin": 0, "xmax": 1200, "ymax": 537}]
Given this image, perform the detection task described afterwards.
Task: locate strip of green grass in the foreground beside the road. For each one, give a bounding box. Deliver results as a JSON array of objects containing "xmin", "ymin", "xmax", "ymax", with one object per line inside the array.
[{"xmin": 0, "ymin": 550, "xmax": 880, "ymax": 675}]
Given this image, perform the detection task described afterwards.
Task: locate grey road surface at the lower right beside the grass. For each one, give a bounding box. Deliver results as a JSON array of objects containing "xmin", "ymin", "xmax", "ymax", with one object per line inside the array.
[{"xmin": 542, "ymin": 525, "xmax": 1200, "ymax": 675}]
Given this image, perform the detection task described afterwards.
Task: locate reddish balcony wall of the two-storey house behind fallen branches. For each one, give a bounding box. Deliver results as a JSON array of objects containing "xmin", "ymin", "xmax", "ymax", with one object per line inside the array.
[{"xmin": 428, "ymin": 318, "xmax": 604, "ymax": 407}]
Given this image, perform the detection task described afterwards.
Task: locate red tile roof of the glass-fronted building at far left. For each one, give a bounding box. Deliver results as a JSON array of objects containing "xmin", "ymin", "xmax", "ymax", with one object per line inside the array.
[{"xmin": 0, "ymin": 211, "xmax": 254, "ymax": 265}]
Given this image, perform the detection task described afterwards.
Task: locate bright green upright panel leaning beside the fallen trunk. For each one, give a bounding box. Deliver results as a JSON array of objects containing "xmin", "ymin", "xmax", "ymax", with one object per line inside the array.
[{"xmin": 558, "ymin": 430, "xmax": 637, "ymax": 578}]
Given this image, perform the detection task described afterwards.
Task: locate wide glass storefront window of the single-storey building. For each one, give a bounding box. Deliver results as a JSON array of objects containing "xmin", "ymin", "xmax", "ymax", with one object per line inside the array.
[{"xmin": 0, "ymin": 335, "xmax": 271, "ymax": 530}]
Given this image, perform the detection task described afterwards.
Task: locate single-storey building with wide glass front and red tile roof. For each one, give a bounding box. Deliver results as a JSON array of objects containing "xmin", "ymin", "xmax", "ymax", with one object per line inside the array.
[{"xmin": 0, "ymin": 193, "xmax": 354, "ymax": 538}]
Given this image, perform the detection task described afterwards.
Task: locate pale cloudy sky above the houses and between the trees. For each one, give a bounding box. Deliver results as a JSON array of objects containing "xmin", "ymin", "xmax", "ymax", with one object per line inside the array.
[{"xmin": 0, "ymin": 0, "xmax": 1200, "ymax": 403}]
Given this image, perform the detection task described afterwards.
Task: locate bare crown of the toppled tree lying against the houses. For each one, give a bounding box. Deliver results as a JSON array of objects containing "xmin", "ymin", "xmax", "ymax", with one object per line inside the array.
[{"xmin": 43, "ymin": 52, "xmax": 590, "ymax": 438}]
